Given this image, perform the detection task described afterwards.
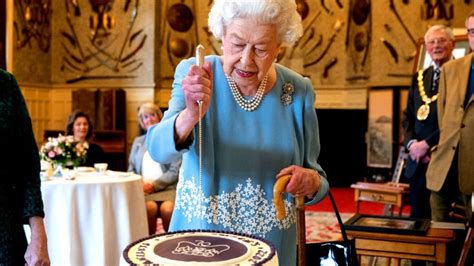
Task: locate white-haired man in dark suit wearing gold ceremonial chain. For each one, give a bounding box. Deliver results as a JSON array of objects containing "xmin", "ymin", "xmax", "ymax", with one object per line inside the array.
[{"xmin": 403, "ymin": 25, "xmax": 454, "ymax": 219}]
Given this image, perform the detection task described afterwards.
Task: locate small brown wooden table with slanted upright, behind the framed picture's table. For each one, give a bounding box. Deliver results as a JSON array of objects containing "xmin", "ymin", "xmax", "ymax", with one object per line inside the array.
[{"xmin": 351, "ymin": 147, "xmax": 410, "ymax": 215}]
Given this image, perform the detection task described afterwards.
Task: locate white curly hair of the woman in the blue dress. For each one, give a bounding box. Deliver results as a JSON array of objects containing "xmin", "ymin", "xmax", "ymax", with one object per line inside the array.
[{"xmin": 208, "ymin": 0, "xmax": 303, "ymax": 46}]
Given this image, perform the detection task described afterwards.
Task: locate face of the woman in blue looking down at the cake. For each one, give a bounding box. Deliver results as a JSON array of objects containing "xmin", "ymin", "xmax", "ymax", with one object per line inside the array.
[{"xmin": 222, "ymin": 19, "xmax": 280, "ymax": 90}]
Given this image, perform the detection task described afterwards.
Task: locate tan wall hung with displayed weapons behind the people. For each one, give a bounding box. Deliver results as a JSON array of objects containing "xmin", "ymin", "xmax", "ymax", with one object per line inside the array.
[{"xmin": 6, "ymin": 0, "xmax": 472, "ymax": 160}]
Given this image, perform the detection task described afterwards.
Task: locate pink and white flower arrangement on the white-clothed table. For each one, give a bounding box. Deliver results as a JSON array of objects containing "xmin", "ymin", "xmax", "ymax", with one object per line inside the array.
[{"xmin": 40, "ymin": 134, "xmax": 87, "ymax": 167}]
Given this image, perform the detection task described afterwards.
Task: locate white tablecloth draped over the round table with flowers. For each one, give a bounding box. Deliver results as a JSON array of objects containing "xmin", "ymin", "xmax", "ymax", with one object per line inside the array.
[{"xmin": 41, "ymin": 172, "xmax": 148, "ymax": 266}]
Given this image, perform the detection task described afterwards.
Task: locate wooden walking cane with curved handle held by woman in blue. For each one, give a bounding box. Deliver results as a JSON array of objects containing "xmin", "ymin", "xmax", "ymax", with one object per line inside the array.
[{"xmin": 273, "ymin": 175, "xmax": 306, "ymax": 266}]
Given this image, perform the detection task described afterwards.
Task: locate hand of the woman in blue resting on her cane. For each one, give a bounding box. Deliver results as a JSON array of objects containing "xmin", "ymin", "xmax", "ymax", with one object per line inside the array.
[{"xmin": 277, "ymin": 165, "xmax": 321, "ymax": 197}]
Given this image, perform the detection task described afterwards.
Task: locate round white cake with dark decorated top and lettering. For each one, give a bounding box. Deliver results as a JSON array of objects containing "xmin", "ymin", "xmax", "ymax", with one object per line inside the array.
[{"xmin": 123, "ymin": 230, "xmax": 278, "ymax": 266}]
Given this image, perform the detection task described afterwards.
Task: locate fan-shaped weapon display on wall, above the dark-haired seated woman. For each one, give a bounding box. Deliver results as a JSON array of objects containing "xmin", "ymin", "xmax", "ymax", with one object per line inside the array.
[{"xmin": 60, "ymin": 0, "xmax": 148, "ymax": 83}]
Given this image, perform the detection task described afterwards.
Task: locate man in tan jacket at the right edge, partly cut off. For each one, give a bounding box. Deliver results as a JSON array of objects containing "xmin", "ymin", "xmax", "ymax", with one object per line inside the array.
[{"xmin": 426, "ymin": 10, "xmax": 474, "ymax": 221}]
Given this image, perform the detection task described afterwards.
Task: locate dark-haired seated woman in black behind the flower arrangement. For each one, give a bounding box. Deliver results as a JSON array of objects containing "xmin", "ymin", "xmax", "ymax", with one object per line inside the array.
[{"xmin": 66, "ymin": 110, "xmax": 104, "ymax": 167}]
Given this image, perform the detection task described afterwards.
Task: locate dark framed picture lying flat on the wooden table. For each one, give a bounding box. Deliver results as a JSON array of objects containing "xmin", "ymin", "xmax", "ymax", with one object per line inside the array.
[{"xmin": 344, "ymin": 213, "xmax": 430, "ymax": 235}]
